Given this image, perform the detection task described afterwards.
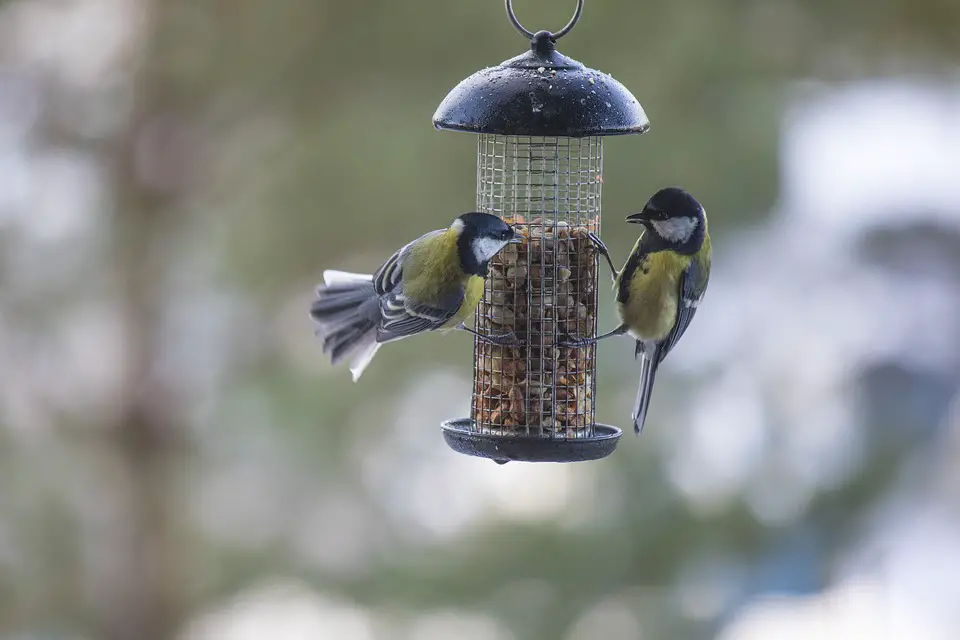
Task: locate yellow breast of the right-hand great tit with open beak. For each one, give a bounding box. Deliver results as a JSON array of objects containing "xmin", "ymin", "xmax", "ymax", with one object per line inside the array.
[{"xmin": 616, "ymin": 251, "xmax": 691, "ymax": 340}]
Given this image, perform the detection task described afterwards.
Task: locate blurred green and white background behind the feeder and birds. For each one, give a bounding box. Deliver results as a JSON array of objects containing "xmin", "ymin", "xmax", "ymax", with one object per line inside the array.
[{"xmin": 0, "ymin": 0, "xmax": 960, "ymax": 640}]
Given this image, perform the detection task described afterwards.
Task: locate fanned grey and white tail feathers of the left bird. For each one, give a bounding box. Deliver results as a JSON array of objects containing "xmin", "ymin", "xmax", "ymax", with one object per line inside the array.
[{"xmin": 310, "ymin": 271, "xmax": 380, "ymax": 382}]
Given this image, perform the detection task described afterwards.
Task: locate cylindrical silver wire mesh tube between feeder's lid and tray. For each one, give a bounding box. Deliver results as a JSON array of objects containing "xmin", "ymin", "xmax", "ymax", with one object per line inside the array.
[{"xmin": 471, "ymin": 135, "xmax": 603, "ymax": 439}]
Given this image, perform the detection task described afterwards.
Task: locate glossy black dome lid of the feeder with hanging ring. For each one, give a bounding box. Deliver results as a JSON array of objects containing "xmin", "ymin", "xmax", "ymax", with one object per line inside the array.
[{"xmin": 433, "ymin": 0, "xmax": 650, "ymax": 138}]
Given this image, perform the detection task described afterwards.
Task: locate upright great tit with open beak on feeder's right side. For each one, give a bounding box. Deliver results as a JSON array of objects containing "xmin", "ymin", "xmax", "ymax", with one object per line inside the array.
[{"xmin": 567, "ymin": 187, "xmax": 711, "ymax": 434}]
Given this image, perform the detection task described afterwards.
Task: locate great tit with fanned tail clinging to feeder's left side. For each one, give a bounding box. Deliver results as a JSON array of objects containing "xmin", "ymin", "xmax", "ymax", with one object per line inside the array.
[{"xmin": 310, "ymin": 212, "xmax": 522, "ymax": 382}]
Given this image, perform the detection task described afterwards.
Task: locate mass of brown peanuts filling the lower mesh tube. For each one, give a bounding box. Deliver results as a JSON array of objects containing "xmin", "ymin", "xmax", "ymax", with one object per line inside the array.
[{"xmin": 472, "ymin": 217, "xmax": 597, "ymax": 438}]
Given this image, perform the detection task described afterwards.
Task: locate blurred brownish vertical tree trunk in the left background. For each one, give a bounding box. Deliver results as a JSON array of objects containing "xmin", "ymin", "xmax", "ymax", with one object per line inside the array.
[{"xmin": 94, "ymin": 0, "xmax": 196, "ymax": 640}]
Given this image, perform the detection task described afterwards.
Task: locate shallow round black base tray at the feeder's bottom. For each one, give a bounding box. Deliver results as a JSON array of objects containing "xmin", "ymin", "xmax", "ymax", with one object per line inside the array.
[{"xmin": 441, "ymin": 418, "xmax": 623, "ymax": 464}]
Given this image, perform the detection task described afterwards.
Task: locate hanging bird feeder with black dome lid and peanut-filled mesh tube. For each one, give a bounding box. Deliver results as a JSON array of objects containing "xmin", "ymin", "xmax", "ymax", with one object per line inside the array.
[{"xmin": 433, "ymin": 0, "xmax": 650, "ymax": 464}]
